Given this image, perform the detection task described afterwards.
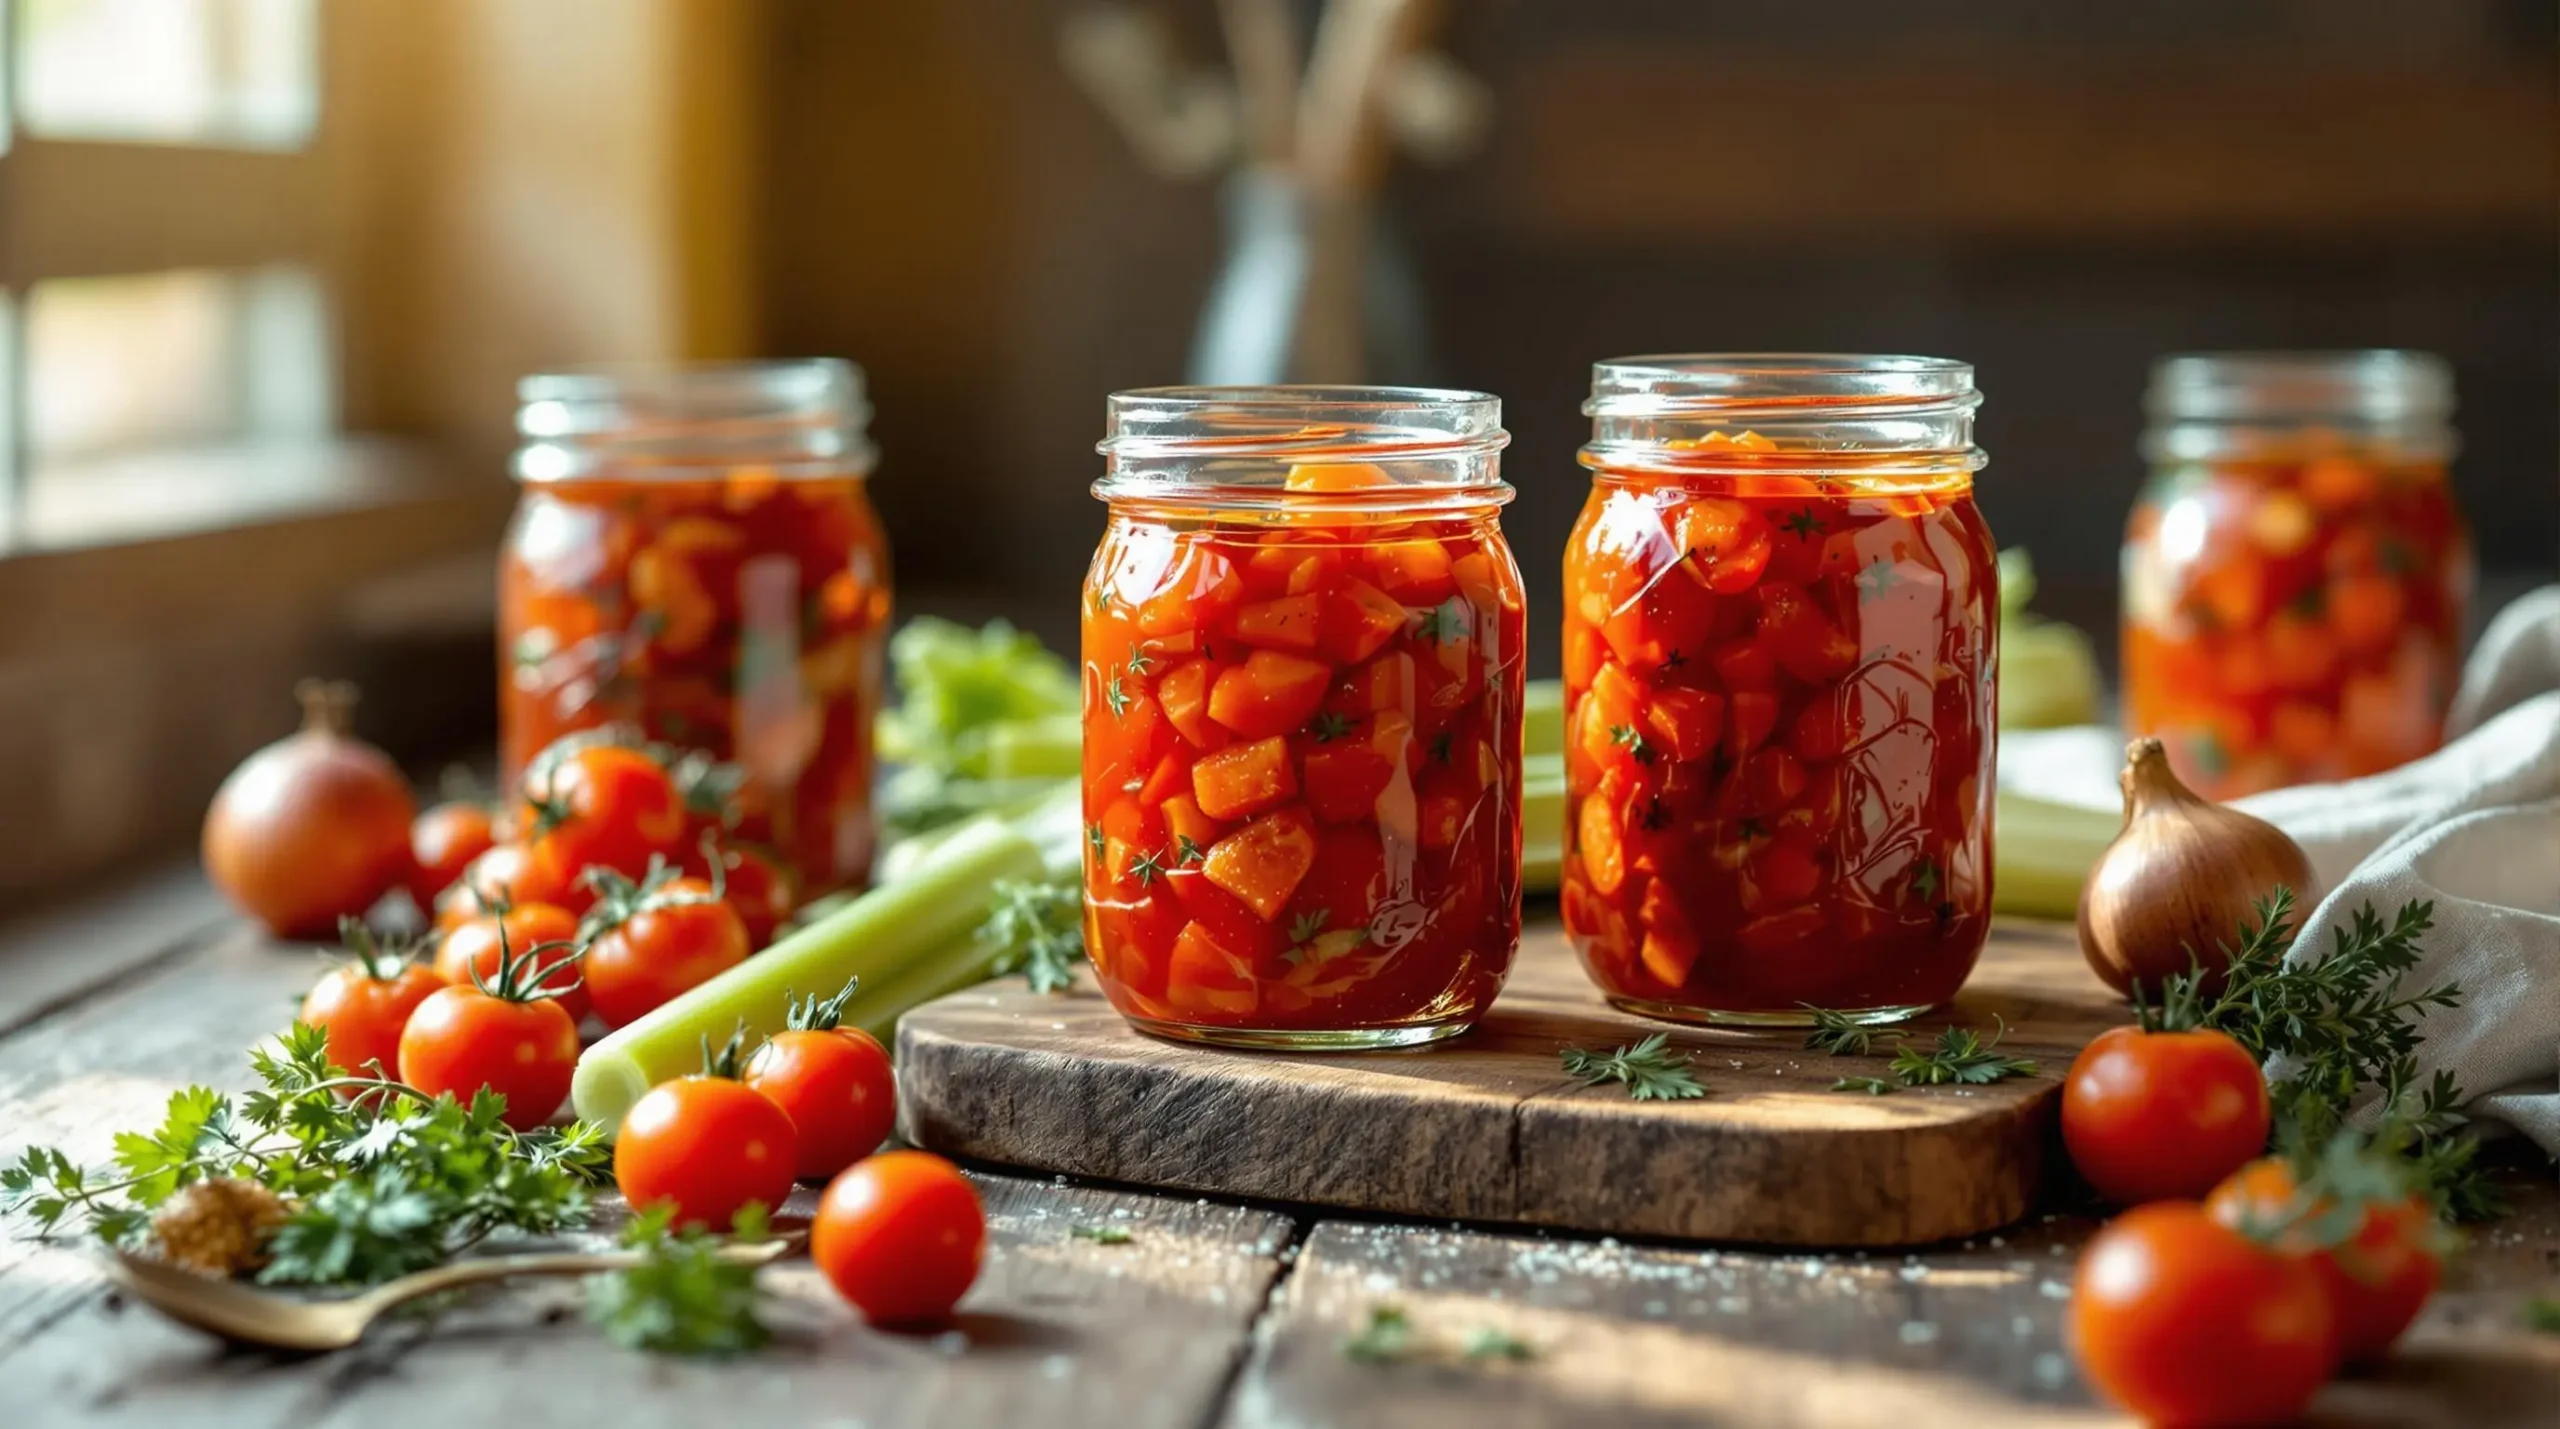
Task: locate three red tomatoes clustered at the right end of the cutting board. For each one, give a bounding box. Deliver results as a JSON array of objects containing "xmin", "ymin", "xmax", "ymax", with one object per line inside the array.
[{"xmin": 2063, "ymin": 1027, "xmax": 2445, "ymax": 1424}]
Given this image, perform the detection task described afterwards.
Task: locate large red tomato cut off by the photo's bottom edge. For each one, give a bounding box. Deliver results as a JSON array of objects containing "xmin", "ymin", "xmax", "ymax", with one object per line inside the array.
[{"xmin": 2071, "ymin": 1201, "xmax": 2337, "ymax": 1426}]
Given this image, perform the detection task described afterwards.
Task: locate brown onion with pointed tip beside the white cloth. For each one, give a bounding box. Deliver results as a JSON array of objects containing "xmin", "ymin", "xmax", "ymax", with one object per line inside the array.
[{"xmin": 2079, "ymin": 740, "xmax": 2317, "ymax": 996}]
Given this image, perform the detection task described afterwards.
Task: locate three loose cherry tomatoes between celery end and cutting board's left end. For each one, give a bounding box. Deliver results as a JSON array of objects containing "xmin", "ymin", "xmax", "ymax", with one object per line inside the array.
[{"xmin": 614, "ymin": 986, "xmax": 986, "ymax": 1324}]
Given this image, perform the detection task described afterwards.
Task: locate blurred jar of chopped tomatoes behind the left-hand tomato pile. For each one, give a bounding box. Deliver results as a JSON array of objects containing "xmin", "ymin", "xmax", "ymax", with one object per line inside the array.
[{"xmin": 499, "ymin": 359, "xmax": 888, "ymax": 894}]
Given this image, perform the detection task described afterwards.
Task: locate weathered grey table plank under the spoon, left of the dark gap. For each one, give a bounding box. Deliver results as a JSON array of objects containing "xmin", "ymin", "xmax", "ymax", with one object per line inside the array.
[{"xmin": 0, "ymin": 935, "xmax": 1293, "ymax": 1429}]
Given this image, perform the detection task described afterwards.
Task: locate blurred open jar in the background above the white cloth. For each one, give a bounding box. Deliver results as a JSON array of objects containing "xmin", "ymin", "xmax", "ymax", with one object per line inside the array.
[{"xmin": 2122, "ymin": 351, "xmax": 2473, "ymax": 799}]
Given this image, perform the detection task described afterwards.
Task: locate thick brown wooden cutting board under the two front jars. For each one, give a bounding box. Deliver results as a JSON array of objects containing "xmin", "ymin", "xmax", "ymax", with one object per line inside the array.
[{"xmin": 899, "ymin": 919, "xmax": 2130, "ymax": 1247}]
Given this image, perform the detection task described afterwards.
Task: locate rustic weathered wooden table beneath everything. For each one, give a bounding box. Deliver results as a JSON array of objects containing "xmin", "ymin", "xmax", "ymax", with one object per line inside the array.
[{"xmin": 0, "ymin": 871, "xmax": 2560, "ymax": 1429}]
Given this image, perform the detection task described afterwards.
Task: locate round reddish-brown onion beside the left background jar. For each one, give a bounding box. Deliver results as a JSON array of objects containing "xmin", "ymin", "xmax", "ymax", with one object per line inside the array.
[{"xmin": 205, "ymin": 679, "xmax": 417, "ymax": 937}]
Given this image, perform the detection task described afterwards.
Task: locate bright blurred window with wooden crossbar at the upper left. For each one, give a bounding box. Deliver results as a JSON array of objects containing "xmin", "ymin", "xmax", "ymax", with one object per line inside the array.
[{"xmin": 0, "ymin": 0, "xmax": 345, "ymax": 553}]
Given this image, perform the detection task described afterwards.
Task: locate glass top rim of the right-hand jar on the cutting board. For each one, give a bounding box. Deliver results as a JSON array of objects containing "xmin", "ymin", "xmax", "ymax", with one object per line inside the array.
[{"xmin": 1582, "ymin": 351, "xmax": 1981, "ymax": 420}]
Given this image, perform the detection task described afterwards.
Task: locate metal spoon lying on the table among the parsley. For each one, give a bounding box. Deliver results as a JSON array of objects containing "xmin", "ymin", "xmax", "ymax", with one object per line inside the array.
[{"xmin": 108, "ymin": 1237, "xmax": 801, "ymax": 1350}]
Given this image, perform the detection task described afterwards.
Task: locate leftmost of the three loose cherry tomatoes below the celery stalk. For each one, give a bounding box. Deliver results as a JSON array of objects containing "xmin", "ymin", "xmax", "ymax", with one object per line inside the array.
[{"xmin": 614, "ymin": 1073, "xmax": 799, "ymax": 1232}]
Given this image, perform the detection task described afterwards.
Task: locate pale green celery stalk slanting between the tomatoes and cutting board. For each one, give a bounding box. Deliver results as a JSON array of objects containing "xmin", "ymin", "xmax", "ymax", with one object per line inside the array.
[{"xmin": 571, "ymin": 799, "xmax": 1049, "ymax": 1127}]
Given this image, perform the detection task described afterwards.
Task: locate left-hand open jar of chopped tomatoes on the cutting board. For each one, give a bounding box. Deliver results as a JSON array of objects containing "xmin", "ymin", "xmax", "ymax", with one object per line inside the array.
[{"xmin": 1083, "ymin": 387, "xmax": 1523, "ymax": 1050}]
